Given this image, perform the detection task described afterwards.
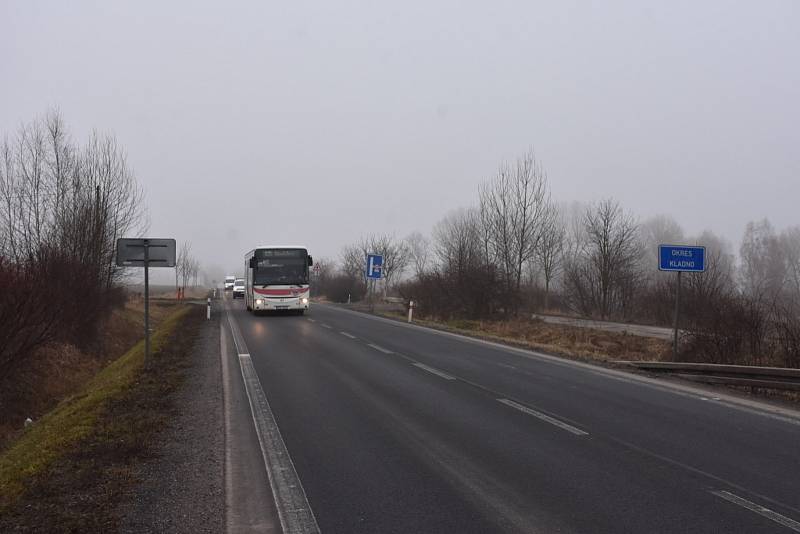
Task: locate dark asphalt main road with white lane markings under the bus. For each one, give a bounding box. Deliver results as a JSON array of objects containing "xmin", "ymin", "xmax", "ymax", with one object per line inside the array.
[{"xmin": 222, "ymin": 301, "xmax": 800, "ymax": 533}]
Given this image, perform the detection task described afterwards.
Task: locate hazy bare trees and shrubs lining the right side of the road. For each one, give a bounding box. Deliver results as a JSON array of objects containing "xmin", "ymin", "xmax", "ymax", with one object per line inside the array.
[{"xmin": 319, "ymin": 152, "xmax": 800, "ymax": 367}]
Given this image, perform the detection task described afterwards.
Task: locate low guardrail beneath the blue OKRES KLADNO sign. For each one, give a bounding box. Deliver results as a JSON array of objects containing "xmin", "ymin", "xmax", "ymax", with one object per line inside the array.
[{"xmin": 614, "ymin": 361, "xmax": 800, "ymax": 391}]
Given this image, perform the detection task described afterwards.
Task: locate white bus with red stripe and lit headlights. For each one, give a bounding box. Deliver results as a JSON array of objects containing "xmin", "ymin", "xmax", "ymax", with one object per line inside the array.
[{"xmin": 244, "ymin": 246, "xmax": 314, "ymax": 315}]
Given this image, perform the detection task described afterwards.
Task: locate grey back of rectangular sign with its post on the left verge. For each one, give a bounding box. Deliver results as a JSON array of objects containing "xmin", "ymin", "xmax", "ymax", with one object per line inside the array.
[{"xmin": 117, "ymin": 237, "xmax": 175, "ymax": 359}]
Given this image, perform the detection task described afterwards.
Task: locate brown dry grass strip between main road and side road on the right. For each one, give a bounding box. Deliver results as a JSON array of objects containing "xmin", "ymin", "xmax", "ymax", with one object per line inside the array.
[{"xmin": 384, "ymin": 313, "xmax": 670, "ymax": 362}]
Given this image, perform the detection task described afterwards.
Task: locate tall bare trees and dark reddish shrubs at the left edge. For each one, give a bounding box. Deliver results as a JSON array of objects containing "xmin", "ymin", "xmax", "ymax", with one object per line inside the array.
[{"xmin": 0, "ymin": 112, "xmax": 146, "ymax": 368}]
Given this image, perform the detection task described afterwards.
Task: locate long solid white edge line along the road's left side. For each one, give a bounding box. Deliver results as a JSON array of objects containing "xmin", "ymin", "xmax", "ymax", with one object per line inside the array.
[{"xmin": 228, "ymin": 313, "xmax": 320, "ymax": 534}]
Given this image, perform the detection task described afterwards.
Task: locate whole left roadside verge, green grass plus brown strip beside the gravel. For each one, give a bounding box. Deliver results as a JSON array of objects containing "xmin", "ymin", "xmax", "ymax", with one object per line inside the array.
[{"xmin": 0, "ymin": 306, "xmax": 204, "ymax": 531}]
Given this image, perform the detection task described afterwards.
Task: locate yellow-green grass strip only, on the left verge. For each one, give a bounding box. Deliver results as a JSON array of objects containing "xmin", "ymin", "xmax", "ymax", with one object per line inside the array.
[{"xmin": 0, "ymin": 306, "xmax": 189, "ymax": 516}]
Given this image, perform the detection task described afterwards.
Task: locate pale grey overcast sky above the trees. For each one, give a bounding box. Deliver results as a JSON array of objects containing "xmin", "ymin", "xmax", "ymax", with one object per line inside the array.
[{"xmin": 0, "ymin": 0, "xmax": 800, "ymax": 284}]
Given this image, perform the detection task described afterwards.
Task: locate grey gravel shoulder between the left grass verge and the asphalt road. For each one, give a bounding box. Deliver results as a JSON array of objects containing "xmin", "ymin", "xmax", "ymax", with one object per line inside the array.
[{"xmin": 118, "ymin": 316, "xmax": 225, "ymax": 533}]
